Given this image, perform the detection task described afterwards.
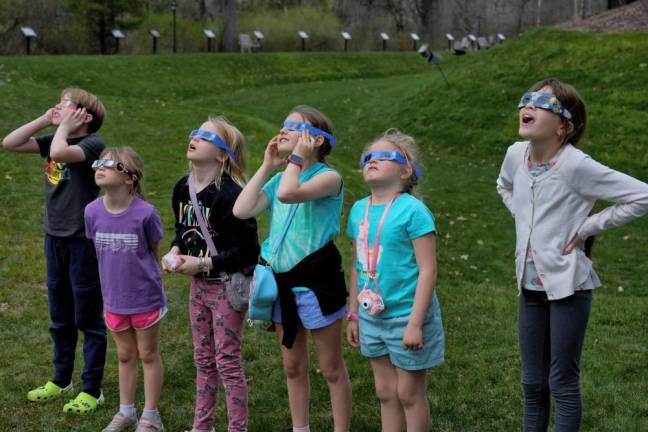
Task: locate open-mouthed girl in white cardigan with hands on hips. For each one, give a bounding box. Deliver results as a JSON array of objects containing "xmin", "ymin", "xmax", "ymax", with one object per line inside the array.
[{"xmin": 497, "ymin": 79, "xmax": 648, "ymax": 431}]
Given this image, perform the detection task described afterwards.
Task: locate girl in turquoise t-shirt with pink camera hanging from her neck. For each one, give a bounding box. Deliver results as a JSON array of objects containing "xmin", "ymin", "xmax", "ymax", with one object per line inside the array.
[{"xmin": 347, "ymin": 129, "xmax": 444, "ymax": 432}]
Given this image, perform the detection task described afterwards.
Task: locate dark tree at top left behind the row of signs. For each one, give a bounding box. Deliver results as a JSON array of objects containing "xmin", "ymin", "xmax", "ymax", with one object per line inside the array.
[{"xmin": 67, "ymin": 0, "xmax": 146, "ymax": 54}]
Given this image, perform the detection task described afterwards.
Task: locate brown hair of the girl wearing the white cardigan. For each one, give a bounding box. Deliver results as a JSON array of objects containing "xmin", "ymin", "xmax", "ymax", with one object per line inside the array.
[{"xmin": 530, "ymin": 78, "xmax": 587, "ymax": 146}]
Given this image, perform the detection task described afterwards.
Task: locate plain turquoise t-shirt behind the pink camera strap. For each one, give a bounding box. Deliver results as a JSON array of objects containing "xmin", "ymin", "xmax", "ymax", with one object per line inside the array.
[{"xmin": 347, "ymin": 194, "xmax": 436, "ymax": 318}]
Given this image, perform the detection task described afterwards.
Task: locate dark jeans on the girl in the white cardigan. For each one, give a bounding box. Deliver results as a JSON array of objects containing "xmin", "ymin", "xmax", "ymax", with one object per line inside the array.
[{"xmin": 518, "ymin": 289, "xmax": 592, "ymax": 432}]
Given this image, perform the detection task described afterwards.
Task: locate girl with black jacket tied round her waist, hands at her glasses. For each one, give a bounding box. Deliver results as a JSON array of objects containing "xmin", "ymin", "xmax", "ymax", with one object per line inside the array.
[{"xmin": 233, "ymin": 106, "xmax": 351, "ymax": 432}]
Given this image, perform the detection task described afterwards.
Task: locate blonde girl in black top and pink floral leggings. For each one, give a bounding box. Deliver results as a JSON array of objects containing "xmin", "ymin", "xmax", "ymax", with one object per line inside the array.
[{"xmin": 163, "ymin": 117, "xmax": 259, "ymax": 431}]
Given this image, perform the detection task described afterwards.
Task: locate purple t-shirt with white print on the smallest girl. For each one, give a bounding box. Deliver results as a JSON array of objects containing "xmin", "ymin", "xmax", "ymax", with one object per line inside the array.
[{"xmin": 85, "ymin": 197, "xmax": 166, "ymax": 314}]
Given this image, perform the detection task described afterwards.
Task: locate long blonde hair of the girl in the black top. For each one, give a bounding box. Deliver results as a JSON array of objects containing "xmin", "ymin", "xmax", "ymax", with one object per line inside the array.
[{"xmin": 196, "ymin": 116, "xmax": 247, "ymax": 189}]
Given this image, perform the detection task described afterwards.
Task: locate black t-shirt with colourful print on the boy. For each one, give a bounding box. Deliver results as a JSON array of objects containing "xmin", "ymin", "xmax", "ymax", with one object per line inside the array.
[{"xmin": 36, "ymin": 134, "xmax": 106, "ymax": 237}]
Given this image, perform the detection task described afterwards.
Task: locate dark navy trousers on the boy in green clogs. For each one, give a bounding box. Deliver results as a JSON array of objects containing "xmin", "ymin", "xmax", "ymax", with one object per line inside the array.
[{"xmin": 45, "ymin": 234, "xmax": 107, "ymax": 390}]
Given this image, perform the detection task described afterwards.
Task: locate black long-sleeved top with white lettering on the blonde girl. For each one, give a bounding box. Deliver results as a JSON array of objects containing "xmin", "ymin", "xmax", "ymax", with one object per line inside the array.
[{"xmin": 171, "ymin": 174, "xmax": 259, "ymax": 278}]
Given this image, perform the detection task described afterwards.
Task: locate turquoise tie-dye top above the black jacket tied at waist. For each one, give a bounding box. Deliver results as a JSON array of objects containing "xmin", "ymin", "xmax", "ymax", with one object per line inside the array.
[{"xmin": 261, "ymin": 162, "xmax": 344, "ymax": 273}]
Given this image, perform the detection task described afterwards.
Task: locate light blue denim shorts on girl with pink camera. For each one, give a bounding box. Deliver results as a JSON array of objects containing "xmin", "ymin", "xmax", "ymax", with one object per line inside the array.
[{"xmin": 360, "ymin": 293, "xmax": 445, "ymax": 370}]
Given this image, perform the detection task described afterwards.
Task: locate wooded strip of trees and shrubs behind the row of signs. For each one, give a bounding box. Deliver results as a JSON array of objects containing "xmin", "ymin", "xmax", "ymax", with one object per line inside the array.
[{"xmin": 0, "ymin": 0, "xmax": 631, "ymax": 54}]
